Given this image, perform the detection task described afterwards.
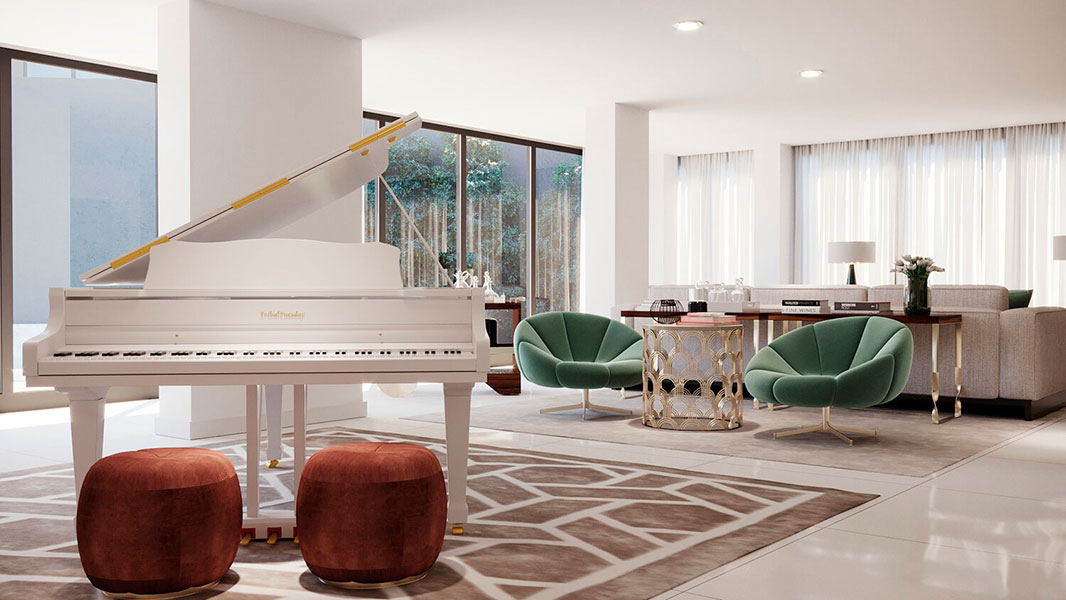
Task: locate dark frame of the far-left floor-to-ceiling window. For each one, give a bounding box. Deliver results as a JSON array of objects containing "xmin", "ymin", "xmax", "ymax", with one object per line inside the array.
[{"xmin": 0, "ymin": 46, "xmax": 159, "ymax": 412}]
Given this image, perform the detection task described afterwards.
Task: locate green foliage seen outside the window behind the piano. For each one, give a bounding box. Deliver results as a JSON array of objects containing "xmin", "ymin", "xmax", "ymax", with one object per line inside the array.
[{"xmin": 367, "ymin": 130, "xmax": 581, "ymax": 311}]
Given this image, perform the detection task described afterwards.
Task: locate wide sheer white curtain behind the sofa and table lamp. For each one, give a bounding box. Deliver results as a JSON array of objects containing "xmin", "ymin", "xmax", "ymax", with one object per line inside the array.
[{"xmin": 794, "ymin": 123, "xmax": 1066, "ymax": 305}]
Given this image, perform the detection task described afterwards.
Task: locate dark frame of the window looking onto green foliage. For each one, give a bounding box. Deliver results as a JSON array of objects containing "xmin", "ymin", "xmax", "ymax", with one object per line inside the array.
[{"xmin": 362, "ymin": 111, "xmax": 584, "ymax": 315}]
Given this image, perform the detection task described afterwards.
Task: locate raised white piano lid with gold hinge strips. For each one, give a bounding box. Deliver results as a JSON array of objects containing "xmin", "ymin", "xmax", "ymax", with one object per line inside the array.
[{"xmin": 81, "ymin": 113, "xmax": 422, "ymax": 286}]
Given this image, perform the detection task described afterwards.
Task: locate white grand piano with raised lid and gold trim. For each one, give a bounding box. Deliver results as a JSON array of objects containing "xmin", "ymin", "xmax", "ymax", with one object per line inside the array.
[{"xmin": 23, "ymin": 114, "xmax": 489, "ymax": 539}]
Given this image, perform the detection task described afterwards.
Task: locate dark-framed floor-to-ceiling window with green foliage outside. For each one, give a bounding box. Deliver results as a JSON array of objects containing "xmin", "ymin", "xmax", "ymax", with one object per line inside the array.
[{"xmin": 364, "ymin": 113, "xmax": 581, "ymax": 314}]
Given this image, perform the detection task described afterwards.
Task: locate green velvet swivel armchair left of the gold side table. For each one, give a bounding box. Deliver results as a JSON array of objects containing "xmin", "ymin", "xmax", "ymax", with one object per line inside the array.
[{"xmin": 515, "ymin": 312, "xmax": 644, "ymax": 419}]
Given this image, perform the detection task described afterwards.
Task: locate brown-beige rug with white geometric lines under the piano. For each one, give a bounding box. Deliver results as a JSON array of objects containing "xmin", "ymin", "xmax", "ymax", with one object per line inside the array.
[{"xmin": 0, "ymin": 428, "xmax": 876, "ymax": 600}]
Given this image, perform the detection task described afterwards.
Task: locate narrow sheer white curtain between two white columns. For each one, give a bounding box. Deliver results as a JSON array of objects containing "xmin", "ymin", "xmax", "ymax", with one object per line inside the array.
[{"xmin": 677, "ymin": 150, "xmax": 755, "ymax": 283}]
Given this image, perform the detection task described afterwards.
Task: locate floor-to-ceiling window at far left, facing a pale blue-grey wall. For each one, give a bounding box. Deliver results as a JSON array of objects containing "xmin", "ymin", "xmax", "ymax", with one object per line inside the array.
[{"xmin": 0, "ymin": 49, "xmax": 157, "ymax": 409}]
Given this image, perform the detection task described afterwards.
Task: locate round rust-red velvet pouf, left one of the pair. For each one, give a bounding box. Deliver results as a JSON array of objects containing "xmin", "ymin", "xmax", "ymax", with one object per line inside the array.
[{"xmin": 77, "ymin": 448, "xmax": 243, "ymax": 598}]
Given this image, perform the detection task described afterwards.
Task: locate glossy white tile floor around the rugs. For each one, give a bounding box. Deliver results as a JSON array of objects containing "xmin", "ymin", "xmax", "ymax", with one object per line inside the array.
[{"xmin": 0, "ymin": 386, "xmax": 1066, "ymax": 600}]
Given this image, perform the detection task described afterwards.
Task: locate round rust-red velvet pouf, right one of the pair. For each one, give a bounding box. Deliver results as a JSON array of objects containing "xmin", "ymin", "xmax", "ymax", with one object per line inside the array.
[{"xmin": 296, "ymin": 442, "xmax": 448, "ymax": 587}]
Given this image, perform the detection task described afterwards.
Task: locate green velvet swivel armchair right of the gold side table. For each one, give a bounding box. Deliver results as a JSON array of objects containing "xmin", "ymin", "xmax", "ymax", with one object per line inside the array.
[{"xmin": 744, "ymin": 317, "xmax": 915, "ymax": 444}]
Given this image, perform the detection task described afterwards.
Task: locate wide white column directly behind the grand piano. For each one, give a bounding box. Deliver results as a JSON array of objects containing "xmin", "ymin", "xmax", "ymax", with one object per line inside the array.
[{"xmin": 157, "ymin": 0, "xmax": 366, "ymax": 438}]
